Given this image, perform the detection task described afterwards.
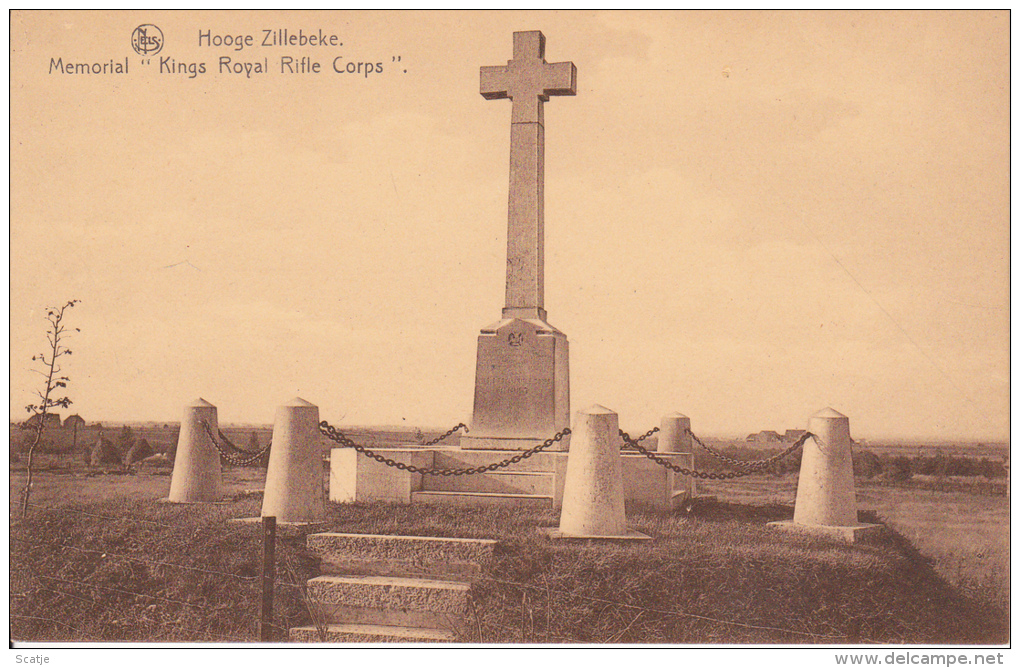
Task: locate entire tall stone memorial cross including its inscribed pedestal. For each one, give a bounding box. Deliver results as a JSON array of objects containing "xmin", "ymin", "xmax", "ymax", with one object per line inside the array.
[{"xmin": 460, "ymin": 31, "xmax": 577, "ymax": 450}]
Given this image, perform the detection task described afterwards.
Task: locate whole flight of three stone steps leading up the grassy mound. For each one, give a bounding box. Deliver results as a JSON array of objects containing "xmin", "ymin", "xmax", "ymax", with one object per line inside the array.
[{"xmin": 291, "ymin": 533, "xmax": 496, "ymax": 643}]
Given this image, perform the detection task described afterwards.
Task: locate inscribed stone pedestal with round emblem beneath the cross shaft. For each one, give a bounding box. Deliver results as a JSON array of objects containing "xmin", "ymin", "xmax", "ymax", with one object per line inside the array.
[{"xmin": 460, "ymin": 316, "xmax": 570, "ymax": 451}]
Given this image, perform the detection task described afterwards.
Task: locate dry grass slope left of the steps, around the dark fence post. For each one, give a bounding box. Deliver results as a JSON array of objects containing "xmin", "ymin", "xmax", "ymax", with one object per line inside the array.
[{"xmin": 10, "ymin": 498, "xmax": 313, "ymax": 643}]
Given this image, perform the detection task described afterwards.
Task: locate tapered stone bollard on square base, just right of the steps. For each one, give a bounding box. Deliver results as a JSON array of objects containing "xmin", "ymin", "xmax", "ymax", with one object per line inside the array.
[{"xmin": 551, "ymin": 404, "xmax": 648, "ymax": 538}]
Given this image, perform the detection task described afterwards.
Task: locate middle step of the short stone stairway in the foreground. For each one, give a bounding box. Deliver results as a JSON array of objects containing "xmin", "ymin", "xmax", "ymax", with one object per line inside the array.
[{"xmin": 308, "ymin": 575, "xmax": 471, "ymax": 615}]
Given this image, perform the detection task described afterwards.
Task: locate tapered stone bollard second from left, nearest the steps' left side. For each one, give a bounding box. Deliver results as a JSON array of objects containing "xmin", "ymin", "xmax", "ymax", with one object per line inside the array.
[{"xmin": 262, "ymin": 399, "xmax": 325, "ymax": 523}]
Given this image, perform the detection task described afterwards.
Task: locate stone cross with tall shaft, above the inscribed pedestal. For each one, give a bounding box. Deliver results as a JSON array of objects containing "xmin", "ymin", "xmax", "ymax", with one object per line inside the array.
[{"xmin": 480, "ymin": 31, "xmax": 577, "ymax": 320}]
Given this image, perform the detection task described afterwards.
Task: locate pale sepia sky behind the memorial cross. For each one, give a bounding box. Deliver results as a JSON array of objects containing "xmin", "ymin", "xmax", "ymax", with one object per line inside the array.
[{"xmin": 10, "ymin": 11, "xmax": 1010, "ymax": 440}]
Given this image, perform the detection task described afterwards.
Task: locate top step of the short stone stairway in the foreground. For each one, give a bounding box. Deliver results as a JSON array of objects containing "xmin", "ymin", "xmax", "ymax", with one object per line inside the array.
[{"xmin": 307, "ymin": 533, "xmax": 496, "ymax": 579}]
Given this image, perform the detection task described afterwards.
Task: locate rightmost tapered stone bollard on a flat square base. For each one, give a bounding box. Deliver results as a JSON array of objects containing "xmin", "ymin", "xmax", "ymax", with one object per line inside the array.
[{"xmin": 772, "ymin": 408, "xmax": 881, "ymax": 543}]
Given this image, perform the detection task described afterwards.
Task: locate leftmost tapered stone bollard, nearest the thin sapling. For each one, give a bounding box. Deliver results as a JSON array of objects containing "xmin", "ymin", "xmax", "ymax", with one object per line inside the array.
[{"xmin": 166, "ymin": 399, "xmax": 222, "ymax": 504}]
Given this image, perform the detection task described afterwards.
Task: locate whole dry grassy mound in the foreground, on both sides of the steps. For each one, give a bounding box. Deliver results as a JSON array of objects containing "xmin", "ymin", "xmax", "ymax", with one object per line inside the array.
[{"xmin": 10, "ymin": 481, "xmax": 1009, "ymax": 645}]
